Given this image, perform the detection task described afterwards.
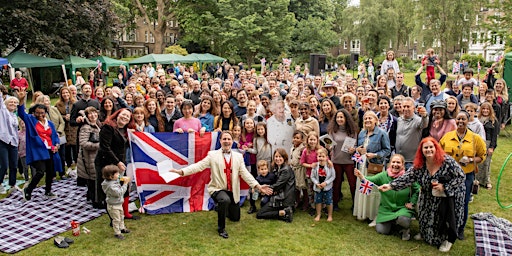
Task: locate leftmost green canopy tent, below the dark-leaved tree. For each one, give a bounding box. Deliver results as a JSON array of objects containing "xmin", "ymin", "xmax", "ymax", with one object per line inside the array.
[{"xmin": 7, "ymin": 51, "xmax": 68, "ymax": 91}]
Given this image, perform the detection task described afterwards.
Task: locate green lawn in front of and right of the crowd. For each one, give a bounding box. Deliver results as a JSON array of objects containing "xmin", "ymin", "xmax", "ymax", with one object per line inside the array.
[{"xmin": 5, "ymin": 71, "xmax": 512, "ymax": 255}]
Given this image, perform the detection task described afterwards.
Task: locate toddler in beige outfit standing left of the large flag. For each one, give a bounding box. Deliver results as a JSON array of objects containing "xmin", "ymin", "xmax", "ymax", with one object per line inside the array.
[{"xmin": 101, "ymin": 165, "xmax": 130, "ymax": 240}]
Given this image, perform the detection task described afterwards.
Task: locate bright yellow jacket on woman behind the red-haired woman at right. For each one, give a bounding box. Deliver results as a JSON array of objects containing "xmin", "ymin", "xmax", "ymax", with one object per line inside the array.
[{"xmin": 439, "ymin": 129, "xmax": 487, "ymax": 173}]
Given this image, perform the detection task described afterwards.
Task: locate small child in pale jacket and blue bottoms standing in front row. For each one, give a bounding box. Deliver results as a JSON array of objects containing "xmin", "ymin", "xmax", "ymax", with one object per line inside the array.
[{"xmin": 311, "ymin": 148, "xmax": 336, "ymax": 221}]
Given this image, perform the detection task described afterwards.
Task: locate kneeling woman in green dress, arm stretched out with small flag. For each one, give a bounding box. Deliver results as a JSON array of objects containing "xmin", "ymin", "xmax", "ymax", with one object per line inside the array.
[{"xmin": 354, "ymin": 154, "xmax": 420, "ymax": 240}]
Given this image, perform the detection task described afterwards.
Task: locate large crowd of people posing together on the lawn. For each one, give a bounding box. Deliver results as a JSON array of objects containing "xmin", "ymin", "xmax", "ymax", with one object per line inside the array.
[{"xmin": 0, "ymin": 51, "xmax": 509, "ymax": 251}]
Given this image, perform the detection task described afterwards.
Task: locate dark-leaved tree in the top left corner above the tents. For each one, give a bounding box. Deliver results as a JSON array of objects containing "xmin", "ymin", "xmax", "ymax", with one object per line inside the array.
[{"xmin": 0, "ymin": 0, "xmax": 117, "ymax": 58}]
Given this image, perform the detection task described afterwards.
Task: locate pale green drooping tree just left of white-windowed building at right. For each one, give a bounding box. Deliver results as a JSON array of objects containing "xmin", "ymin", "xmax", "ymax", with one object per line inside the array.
[{"xmin": 416, "ymin": 0, "xmax": 477, "ymax": 67}]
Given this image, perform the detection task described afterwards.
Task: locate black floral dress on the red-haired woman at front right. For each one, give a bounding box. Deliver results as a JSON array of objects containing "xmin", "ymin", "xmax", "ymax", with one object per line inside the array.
[{"xmin": 390, "ymin": 155, "xmax": 466, "ymax": 246}]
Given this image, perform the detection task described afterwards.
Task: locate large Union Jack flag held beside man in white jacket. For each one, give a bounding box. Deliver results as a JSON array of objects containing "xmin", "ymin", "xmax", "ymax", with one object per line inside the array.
[{"xmin": 129, "ymin": 132, "xmax": 248, "ymax": 214}]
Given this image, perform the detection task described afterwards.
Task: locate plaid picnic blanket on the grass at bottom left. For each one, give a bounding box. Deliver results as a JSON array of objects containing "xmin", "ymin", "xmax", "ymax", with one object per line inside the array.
[{"xmin": 0, "ymin": 179, "xmax": 105, "ymax": 253}]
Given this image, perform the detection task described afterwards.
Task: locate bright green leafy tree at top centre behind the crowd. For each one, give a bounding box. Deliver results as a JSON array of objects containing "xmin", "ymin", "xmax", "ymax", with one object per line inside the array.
[{"xmin": 218, "ymin": 0, "xmax": 295, "ymax": 67}]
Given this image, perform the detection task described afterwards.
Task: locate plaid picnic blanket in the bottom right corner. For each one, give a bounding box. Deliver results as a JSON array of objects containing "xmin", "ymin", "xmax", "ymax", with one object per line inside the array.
[{"xmin": 471, "ymin": 213, "xmax": 512, "ymax": 255}]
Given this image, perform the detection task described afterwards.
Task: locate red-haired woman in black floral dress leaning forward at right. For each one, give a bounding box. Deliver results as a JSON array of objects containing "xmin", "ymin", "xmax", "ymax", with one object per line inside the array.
[{"xmin": 379, "ymin": 137, "xmax": 466, "ymax": 252}]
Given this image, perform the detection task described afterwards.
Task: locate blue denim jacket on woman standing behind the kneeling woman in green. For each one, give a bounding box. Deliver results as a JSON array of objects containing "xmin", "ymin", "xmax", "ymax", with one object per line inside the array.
[{"xmin": 357, "ymin": 127, "xmax": 391, "ymax": 164}]
